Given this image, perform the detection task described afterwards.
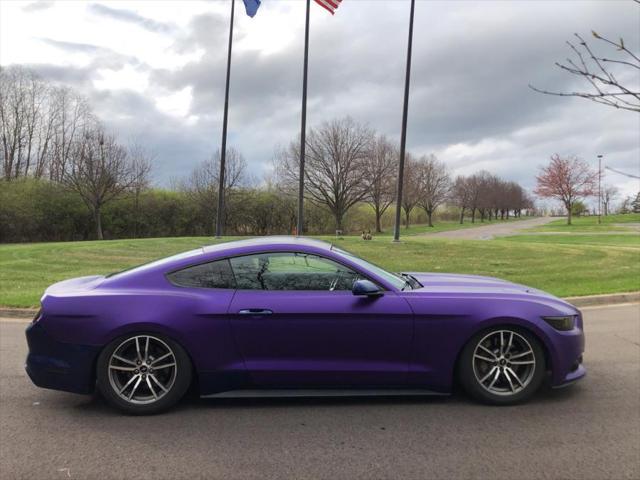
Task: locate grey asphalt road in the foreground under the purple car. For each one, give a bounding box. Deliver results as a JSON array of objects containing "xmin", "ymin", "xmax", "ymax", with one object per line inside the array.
[{"xmin": 0, "ymin": 304, "xmax": 640, "ymax": 480}]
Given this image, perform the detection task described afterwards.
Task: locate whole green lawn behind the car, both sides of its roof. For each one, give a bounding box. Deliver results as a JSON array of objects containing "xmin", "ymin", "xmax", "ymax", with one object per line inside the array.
[{"xmin": 0, "ymin": 235, "xmax": 640, "ymax": 307}]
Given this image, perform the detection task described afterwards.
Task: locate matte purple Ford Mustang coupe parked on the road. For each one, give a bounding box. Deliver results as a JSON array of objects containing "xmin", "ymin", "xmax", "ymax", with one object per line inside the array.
[{"xmin": 26, "ymin": 237, "xmax": 585, "ymax": 414}]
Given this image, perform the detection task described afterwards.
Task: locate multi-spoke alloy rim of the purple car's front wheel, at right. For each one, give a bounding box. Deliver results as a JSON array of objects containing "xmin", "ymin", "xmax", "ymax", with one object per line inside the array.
[{"xmin": 472, "ymin": 330, "xmax": 536, "ymax": 396}]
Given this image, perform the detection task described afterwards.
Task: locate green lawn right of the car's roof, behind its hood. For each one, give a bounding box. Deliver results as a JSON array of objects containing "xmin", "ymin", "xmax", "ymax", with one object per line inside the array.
[{"xmin": 328, "ymin": 238, "xmax": 640, "ymax": 297}]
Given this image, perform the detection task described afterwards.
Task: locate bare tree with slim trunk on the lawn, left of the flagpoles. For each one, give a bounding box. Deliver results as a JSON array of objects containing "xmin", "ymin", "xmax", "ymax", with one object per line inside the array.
[{"xmin": 63, "ymin": 125, "xmax": 133, "ymax": 240}]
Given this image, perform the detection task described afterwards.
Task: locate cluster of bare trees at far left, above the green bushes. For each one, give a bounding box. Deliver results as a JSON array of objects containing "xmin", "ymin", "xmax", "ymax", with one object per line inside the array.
[{"xmin": 0, "ymin": 67, "xmax": 152, "ymax": 239}]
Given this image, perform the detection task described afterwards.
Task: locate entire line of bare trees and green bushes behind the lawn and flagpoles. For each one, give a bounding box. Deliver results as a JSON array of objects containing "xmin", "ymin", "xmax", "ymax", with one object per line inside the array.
[{"xmin": 0, "ymin": 67, "xmax": 533, "ymax": 242}]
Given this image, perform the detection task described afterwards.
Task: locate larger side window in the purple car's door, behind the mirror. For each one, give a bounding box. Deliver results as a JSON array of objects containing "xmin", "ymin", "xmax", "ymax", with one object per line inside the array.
[{"xmin": 231, "ymin": 252, "xmax": 359, "ymax": 291}]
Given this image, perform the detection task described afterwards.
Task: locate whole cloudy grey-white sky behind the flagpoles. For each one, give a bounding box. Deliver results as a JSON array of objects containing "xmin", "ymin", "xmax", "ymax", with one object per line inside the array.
[{"xmin": 0, "ymin": 0, "xmax": 640, "ymax": 201}]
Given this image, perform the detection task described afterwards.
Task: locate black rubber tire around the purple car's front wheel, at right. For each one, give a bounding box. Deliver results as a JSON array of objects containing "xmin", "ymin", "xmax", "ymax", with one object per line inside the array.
[{"xmin": 458, "ymin": 325, "xmax": 546, "ymax": 405}]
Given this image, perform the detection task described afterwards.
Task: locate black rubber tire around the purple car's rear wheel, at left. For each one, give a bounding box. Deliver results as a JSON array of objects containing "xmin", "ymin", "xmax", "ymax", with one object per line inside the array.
[{"xmin": 96, "ymin": 333, "xmax": 192, "ymax": 415}]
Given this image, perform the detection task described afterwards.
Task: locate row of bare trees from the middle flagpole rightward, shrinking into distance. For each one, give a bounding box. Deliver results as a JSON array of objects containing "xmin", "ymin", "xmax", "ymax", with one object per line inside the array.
[{"xmin": 275, "ymin": 117, "xmax": 533, "ymax": 232}]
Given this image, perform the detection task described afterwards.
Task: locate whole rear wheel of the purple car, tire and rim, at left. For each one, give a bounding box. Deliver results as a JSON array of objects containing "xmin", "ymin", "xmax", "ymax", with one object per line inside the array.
[{"xmin": 97, "ymin": 334, "xmax": 191, "ymax": 415}]
